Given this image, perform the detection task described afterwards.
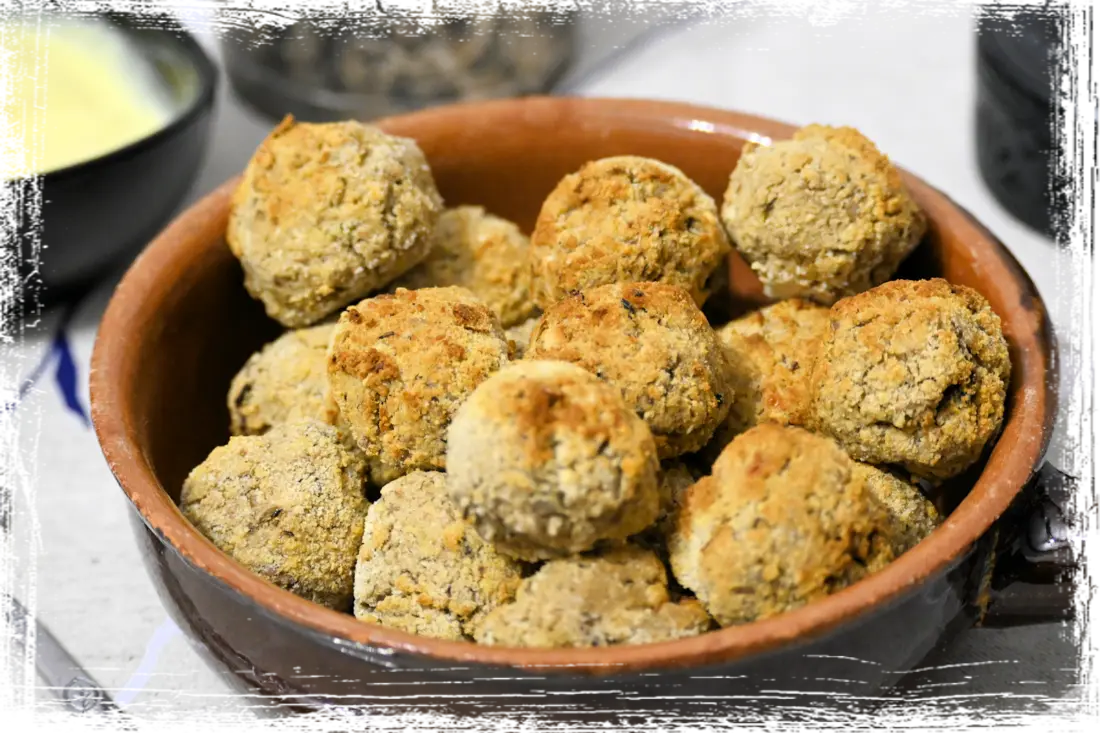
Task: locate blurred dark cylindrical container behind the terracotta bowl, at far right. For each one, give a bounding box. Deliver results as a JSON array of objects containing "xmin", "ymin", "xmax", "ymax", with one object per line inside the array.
[{"xmin": 976, "ymin": 0, "xmax": 1100, "ymax": 250}]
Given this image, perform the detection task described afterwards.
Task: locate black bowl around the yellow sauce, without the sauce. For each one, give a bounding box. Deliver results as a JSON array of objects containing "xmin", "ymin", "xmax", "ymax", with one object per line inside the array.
[{"xmin": 0, "ymin": 0, "xmax": 218, "ymax": 314}]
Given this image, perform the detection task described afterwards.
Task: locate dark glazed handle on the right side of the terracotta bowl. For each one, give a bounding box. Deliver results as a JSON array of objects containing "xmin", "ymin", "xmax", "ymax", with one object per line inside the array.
[{"xmin": 978, "ymin": 463, "xmax": 1100, "ymax": 628}]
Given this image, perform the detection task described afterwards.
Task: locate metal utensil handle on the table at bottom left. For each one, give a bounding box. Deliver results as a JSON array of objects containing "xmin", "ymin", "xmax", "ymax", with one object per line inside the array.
[{"xmin": 0, "ymin": 588, "xmax": 141, "ymax": 733}]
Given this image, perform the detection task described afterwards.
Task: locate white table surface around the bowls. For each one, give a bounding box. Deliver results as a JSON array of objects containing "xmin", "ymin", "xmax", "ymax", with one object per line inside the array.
[{"xmin": 0, "ymin": 0, "xmax": 1100, "ymax": 733}]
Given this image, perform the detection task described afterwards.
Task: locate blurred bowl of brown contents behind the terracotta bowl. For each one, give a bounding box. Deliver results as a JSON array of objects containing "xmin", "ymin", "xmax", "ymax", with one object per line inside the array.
[{"xmin": 219, "ymin": 0, "xmax": 575, "ymax": 121}]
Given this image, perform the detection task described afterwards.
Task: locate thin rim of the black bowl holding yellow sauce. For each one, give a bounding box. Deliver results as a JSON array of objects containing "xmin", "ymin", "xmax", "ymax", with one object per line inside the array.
[{"xmin": 0, "ymin": 0, "xmax": 220, "ymax": 191}]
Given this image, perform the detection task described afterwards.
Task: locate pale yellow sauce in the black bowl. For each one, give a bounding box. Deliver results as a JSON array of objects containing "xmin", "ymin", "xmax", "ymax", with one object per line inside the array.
[{"xmin": 0, "ymin": 7, "xmax": 172, "ymax": 186}]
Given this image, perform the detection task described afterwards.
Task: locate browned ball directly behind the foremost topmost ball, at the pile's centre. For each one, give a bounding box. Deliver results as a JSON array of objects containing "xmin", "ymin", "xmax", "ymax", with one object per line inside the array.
[{"xmin": 525, "ymin": 283, "xmax": 734, "ymax": 458}]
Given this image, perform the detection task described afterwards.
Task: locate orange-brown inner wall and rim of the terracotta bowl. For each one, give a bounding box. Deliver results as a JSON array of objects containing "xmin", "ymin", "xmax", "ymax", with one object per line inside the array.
[{"xmin": 91, "ymin": 99, "xmax": 1057, "ymax": 674}]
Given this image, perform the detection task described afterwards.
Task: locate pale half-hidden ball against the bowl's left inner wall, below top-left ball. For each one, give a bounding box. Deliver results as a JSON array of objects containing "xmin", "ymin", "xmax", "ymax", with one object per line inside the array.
[{"xmin": 228, "ymin": 324, "xmax": 336, "ymax": 435}]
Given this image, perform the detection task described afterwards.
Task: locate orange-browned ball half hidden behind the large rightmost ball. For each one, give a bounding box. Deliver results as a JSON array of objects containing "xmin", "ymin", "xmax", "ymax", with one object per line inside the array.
[{"xmin": 718, "ymin": 299, "xmax": 829, "ymax": 448}]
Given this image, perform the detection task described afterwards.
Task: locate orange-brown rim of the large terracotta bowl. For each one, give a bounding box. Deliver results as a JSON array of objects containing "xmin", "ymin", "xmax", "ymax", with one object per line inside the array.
[{"xmin": 90, "ymin": 97, "xmax": 1058, "ymax": 675}]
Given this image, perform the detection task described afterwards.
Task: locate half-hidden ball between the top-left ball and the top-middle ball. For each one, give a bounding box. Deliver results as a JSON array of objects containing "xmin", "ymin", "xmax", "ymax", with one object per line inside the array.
[{"xmin": 397, "ymin": 206, "xmax": 536, "ymax": 328}]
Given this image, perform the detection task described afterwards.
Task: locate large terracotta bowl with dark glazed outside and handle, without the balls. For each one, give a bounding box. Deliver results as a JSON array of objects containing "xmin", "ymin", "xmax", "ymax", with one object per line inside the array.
[{"xmin": 91, "ymin": 99, "xmax": 1100, "ymax": 733}]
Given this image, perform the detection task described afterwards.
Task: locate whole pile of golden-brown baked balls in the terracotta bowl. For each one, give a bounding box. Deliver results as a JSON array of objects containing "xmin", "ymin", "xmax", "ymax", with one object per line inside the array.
[{"xmin": 180, "ymin": 118, "xmax": 1010, "ymax": 647}]
